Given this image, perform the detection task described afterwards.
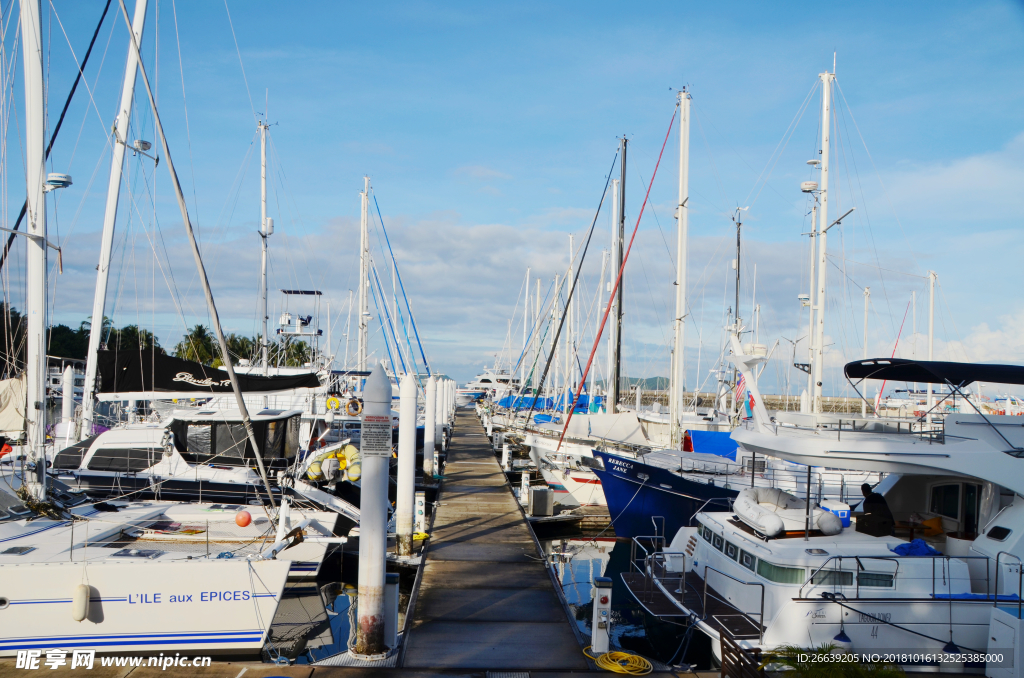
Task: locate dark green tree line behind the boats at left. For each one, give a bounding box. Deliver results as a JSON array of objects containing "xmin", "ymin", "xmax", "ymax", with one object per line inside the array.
[{"xmin": 0, "ymin": 302, "xmax": 312, "ymax": 376}]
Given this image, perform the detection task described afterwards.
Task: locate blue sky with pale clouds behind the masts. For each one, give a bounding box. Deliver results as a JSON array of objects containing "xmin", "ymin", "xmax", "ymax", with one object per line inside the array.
[{"xmin": 5, "ymin": 0, "xmax": 1024, "ymax": 386}]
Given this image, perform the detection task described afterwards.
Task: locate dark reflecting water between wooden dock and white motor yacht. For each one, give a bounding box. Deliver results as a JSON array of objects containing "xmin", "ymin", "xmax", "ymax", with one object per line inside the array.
[{"xmin": 541, "ymin": 537, "xmax": 711, "ymax": 669}]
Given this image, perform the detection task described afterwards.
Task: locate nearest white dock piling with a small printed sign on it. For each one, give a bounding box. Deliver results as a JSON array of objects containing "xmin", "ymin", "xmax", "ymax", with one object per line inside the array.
[{"xmin": 353, "ymin": 364, "xmax": 391, "ymax": 660}]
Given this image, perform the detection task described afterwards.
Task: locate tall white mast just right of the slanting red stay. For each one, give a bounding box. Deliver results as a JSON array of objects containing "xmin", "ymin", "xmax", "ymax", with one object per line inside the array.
[{"xmin": 669, "ymin": 90, "xmax": 690, "ymax": 449}]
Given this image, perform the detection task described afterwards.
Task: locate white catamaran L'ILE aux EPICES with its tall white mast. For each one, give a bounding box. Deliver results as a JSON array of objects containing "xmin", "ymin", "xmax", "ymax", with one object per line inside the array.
[{"xmin": 0, "ymin": 0, "xmax": 321, "ymax": 655}]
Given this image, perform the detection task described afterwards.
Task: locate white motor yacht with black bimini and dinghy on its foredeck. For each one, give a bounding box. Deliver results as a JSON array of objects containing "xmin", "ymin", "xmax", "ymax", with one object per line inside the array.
[{"xmin": 625, "ymin": 345, "xmax": 1024, "ymax": 675}]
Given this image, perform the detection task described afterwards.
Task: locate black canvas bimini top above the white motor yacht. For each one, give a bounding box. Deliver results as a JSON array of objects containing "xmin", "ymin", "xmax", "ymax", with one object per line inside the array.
[{"xmin": 843, "ymin": 357, "xmax": 1024, "ymax": 388}]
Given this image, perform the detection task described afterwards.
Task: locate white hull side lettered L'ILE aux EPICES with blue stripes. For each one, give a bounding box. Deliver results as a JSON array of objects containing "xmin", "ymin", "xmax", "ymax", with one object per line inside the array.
[{"xmin": 0, "ymin": 558, "xmax": 291, "ymax": 665}]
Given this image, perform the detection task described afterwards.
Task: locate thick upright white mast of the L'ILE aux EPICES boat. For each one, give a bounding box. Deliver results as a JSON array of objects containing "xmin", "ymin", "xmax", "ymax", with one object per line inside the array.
[{"xmin": 20, "ymin": 0, "xmax": 46, "ymax": 501}]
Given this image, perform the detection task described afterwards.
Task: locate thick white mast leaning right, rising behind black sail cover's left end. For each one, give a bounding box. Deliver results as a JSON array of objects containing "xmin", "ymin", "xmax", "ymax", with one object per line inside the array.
[{"xmin": 80, "ymin": 0, "xmax": 148, "ymax": 440}]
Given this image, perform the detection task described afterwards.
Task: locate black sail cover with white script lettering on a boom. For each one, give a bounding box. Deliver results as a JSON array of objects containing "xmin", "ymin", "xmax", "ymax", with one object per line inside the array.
[{"xmin": 97, "ymin": 350, "xmax": 321, "ymax": 393}]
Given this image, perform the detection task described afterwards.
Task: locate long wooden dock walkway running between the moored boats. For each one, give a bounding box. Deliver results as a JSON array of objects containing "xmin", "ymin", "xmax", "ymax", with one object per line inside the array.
[{"xmin": 399, "ymin": 411, "xmax": 589, "ymax": 671}]
